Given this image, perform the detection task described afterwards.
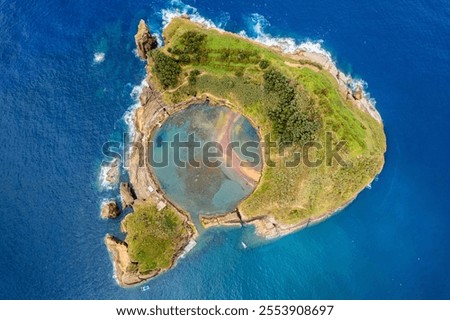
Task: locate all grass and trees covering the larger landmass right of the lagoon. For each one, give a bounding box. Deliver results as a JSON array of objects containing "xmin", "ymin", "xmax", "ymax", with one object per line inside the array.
[{"xmin": 149, "ymin": 19, "xmax": 386, "ymax": 223}]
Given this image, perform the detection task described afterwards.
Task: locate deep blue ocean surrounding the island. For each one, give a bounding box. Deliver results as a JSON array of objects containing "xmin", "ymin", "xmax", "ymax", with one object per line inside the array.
[{"xmin": 0, "ymin": 0, "xmax": 450, "ymax": 299}]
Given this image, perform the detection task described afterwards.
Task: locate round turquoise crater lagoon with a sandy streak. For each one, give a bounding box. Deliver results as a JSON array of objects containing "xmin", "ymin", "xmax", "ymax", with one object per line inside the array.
[{"xmin": 151, "ymin": 104, "xmax": 262, "ymax": 218}]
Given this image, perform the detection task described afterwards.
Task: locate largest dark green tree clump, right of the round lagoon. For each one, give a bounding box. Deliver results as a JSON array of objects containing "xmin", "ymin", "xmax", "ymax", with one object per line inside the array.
[{"xmin": 264, "ymin": 68, "xmax": 320, "ymax": 143}]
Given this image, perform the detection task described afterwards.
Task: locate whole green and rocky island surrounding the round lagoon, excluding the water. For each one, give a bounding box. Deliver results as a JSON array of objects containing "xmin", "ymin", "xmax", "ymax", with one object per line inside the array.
[{"xmin": 105, "ymin": 17, "xmax": 386, "ymax": 286}]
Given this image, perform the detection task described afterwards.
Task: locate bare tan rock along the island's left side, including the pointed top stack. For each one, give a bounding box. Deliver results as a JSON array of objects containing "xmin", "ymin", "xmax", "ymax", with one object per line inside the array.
[{"xmin": 105, "ymin": 20, "xmax": 198, "ymax": 287}]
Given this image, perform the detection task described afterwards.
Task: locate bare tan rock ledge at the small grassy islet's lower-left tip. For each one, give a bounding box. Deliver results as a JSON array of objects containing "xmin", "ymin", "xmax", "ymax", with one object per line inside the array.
[{"xmin": 105, "ymin": 234, "xmax": 157, "ymax": 287}]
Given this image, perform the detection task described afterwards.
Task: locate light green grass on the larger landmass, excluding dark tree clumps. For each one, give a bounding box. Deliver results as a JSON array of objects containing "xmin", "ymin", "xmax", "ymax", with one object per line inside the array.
[{"xmin": 156, "ymin": 19, "xmax": 386, "ymax": 223}]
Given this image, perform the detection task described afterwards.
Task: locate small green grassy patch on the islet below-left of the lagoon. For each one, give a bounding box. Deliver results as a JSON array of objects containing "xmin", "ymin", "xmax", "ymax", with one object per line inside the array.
[{"xmin": 125, "ymin": 205, "xmax": 187, "ymax": 274}]
